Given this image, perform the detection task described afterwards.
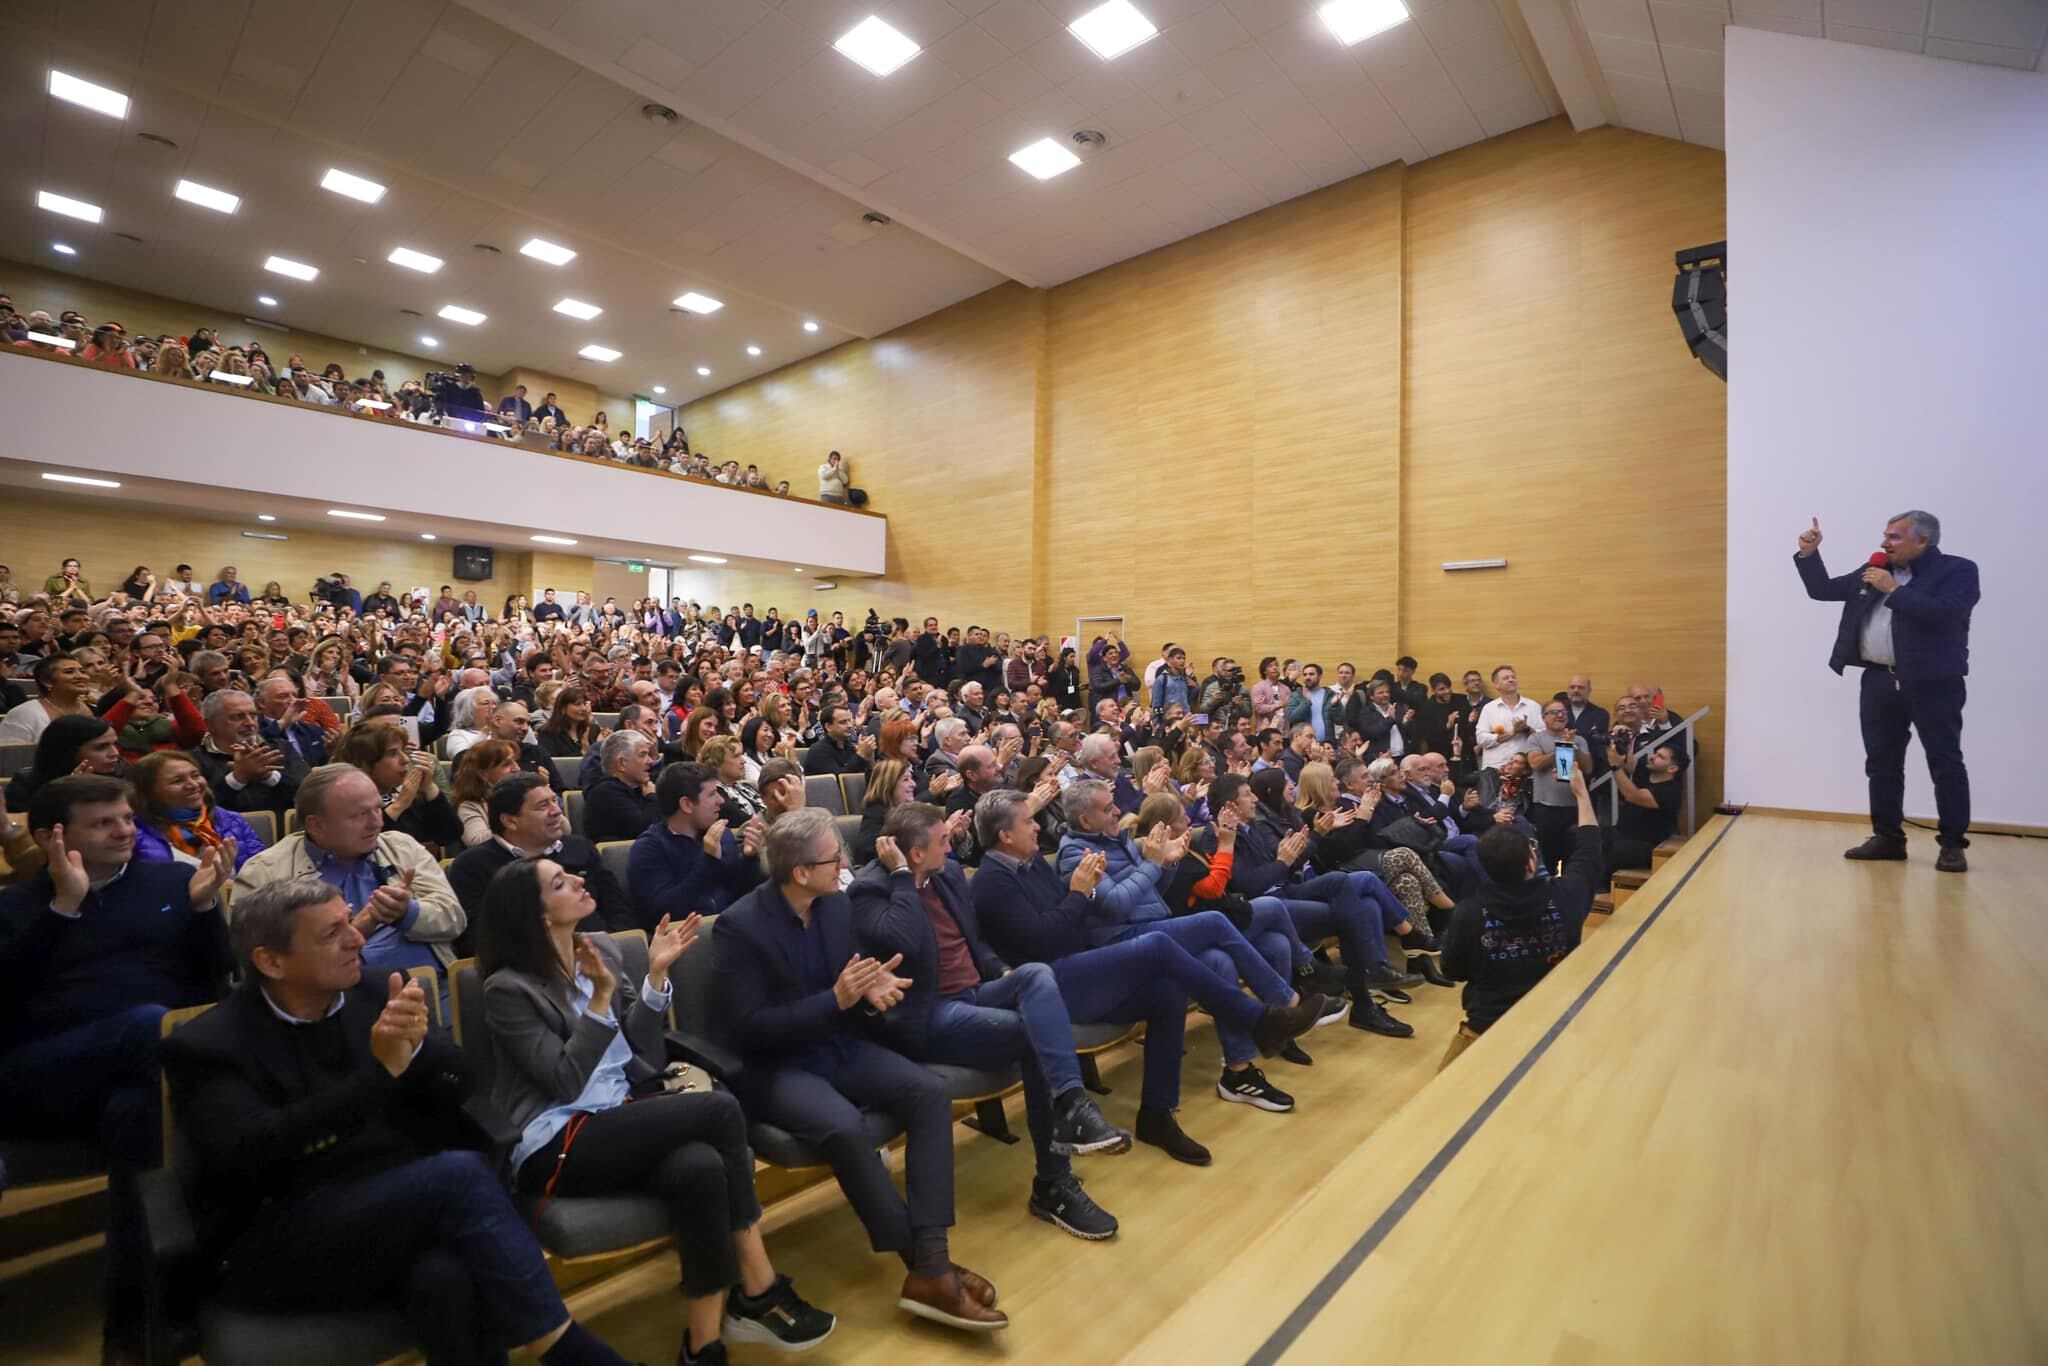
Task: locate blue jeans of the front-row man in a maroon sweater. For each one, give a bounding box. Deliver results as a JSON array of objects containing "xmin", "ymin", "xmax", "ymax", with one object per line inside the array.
[{"xmin": 924, "ymin": 963, "xmax": 1081, "ymax": 1176}]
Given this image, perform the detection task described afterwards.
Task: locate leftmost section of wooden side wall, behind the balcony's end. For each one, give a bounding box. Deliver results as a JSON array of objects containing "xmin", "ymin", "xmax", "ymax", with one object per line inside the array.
[{"xmin": 678, "ymin": 285, "xmax": 1044, "ymax": 629}]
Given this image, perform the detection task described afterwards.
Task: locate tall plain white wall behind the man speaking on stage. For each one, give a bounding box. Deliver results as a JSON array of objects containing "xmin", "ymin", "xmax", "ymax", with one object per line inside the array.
[{"xmin": 1726, "ymin": 29, "xmax": 2048, "ymax": 825}]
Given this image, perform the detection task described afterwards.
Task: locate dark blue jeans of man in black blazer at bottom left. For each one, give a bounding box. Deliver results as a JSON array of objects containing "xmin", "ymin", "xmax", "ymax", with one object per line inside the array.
[{"xmin": 221, "ymin": 1151, "xmax": 569, "ymax": 1366}]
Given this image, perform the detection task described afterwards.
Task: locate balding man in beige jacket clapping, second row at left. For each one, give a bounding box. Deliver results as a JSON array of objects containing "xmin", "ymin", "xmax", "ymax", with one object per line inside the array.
[{"xmin": 229, "ymin": 764, "xmax": 469, "ymax": 1003}]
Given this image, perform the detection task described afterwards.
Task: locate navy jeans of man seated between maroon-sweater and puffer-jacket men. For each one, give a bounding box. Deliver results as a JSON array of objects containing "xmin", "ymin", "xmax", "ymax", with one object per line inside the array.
[{"xmin": 1053, "ymin": 934, "xmax": 1262, "ymax": 1081}]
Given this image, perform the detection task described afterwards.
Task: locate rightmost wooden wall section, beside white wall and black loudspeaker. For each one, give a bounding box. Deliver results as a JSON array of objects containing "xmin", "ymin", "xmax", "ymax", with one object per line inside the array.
[{"xmin": 1401, "ymin": 121, "xmax": 1726, "ymax": 799}]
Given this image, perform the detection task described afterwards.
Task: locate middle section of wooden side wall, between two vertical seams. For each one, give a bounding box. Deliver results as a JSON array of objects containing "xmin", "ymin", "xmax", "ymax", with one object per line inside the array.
[{"xmin": 1036, "ymin": 166, "xmax": 1405, "ymax": 668}]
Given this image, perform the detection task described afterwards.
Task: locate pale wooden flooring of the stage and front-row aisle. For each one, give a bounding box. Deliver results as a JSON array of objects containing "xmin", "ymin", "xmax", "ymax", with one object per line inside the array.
[{"xmin": 0, "ymin": 815, "xmax": 2048, "ymax": 1366}]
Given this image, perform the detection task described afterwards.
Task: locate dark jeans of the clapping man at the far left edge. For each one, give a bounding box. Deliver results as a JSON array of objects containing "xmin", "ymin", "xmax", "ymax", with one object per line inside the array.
[{"xmin": 0, "ymin": 1006, "xmax": 164, "ymax": 1343}]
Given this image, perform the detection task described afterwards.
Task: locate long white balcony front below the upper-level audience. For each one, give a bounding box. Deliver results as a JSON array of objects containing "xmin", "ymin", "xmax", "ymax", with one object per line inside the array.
[{"xmin": 0, "ymin": 354, "xmax": 889, "ymax": 573}]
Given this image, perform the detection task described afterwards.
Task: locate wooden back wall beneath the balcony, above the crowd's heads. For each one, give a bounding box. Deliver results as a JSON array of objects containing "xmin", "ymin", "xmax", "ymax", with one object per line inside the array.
[{"xmin": 0, "ymin": 492, "xmax": 528, "ymax": 610}]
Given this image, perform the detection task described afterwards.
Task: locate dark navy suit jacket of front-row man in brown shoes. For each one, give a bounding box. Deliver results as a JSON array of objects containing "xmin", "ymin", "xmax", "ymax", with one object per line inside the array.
[{"xmin": 711, "ymin": 883, "xmax": 874, "ymax": 1065}]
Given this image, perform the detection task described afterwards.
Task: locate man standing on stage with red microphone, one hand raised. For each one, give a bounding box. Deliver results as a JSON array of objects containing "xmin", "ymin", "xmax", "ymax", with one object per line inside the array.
[{"xmin": 1792, "ymin": 512, "xmax": 1978, "ymax": 872}]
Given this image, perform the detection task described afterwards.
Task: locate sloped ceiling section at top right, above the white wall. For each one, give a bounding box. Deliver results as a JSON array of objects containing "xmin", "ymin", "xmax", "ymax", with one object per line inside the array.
[{"xmin": 1577, "ymin": 0, "xmax": 2048, "ymax": 147}]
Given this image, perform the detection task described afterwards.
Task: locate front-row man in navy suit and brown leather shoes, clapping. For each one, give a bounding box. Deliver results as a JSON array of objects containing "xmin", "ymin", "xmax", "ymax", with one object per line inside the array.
[{"xmin": 716, "ymin": 810, "xmax": 1010, "ymax": 1331}]
